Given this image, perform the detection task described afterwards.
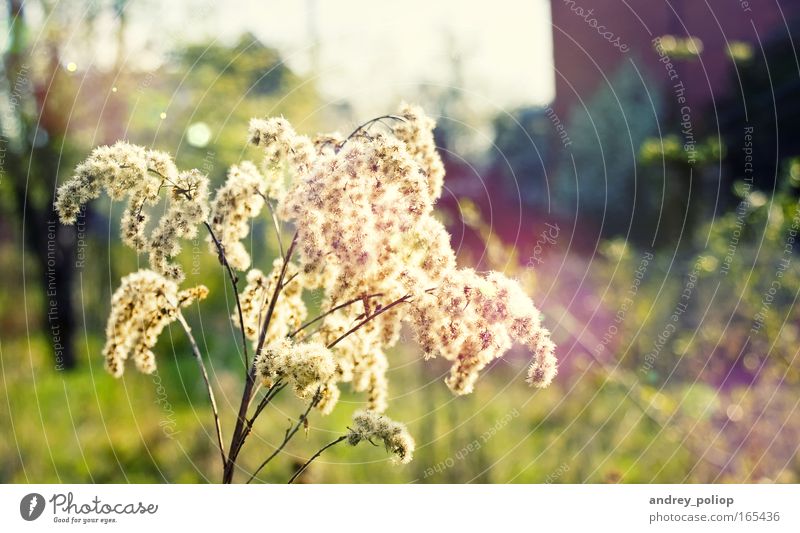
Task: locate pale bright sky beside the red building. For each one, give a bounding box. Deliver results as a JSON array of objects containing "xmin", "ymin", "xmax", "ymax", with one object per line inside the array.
[{"xmin": 131, "ymin": 0, "xmax": 554, "ymax": 116}]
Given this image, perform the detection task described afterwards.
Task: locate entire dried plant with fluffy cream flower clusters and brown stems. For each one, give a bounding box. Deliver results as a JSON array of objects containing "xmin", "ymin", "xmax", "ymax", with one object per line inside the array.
[{"xmin": 56, "ymin": 104, "xmax": 557, "ymax": 483}]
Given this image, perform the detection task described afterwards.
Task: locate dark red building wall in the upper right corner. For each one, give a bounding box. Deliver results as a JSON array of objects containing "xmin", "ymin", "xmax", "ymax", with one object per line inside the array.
[{"xmin": 551, "ymin": 0, "xmax": 800, "ymax": 117}]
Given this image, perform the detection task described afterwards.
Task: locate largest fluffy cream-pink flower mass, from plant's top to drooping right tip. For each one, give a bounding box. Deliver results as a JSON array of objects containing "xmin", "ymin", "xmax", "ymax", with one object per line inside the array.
[{"xmin": 250, "ymin": 105, "xmax": 557, "ymax": 394}]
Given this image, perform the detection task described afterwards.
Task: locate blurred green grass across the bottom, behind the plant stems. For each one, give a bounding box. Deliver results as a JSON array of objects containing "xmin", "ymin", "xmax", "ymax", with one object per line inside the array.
[{"xmin": 0, "ymin": 242, "xmax": 800, "ymax": 483}]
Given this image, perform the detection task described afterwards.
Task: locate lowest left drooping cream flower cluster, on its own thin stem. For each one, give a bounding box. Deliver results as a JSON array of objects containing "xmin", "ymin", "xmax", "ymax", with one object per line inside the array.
[{"xmin": 103, "ymin": 270, "xmax": 208, "ymax": 377}]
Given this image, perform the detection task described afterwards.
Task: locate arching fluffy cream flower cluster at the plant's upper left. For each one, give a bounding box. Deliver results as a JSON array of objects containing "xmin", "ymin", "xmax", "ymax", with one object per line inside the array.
[{"xmin": 55, "ymin": 141, "xmax": 208, "ymax": 281}]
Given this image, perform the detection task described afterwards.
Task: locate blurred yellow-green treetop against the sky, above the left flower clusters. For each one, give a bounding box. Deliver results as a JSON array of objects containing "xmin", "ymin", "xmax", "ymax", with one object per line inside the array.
[{"xmin": 130, "ymin": 34, "xmax": 319, "ymax": 182}]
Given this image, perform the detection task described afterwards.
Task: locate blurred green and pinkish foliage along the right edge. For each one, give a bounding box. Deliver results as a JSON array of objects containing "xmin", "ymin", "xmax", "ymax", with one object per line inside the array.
[{"xmin": 594, "ymin": 165, "xmax": 800, "ymax": 481}]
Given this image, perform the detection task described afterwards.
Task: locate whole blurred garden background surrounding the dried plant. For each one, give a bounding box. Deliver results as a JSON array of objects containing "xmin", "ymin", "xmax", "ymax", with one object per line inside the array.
[{"xmin": 0, "ymin": 0, "xmax": 800, "ymax": 483}]
